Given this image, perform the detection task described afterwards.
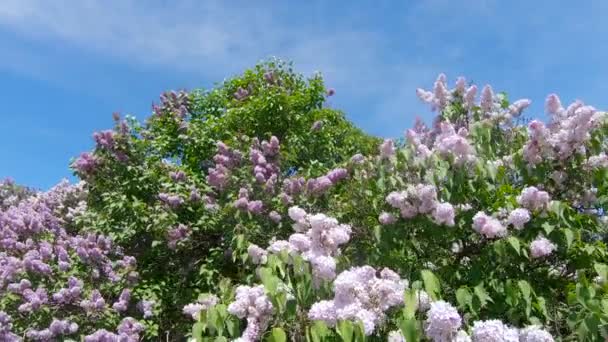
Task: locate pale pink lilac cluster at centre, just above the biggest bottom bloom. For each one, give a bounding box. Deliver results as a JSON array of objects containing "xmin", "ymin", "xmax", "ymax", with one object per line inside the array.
[{"xmin": 248, "ymin": 206, "xmax": 351, "ymax": 284}]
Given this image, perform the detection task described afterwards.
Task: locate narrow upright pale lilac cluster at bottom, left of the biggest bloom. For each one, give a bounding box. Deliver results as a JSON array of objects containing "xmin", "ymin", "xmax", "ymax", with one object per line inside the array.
[{"xmin": 228, "ymin": 285, "xmax": 274, "ymax": 342}]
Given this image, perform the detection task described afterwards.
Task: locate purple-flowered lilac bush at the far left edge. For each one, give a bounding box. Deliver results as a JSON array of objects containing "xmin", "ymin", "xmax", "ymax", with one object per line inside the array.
[{"xmin": 0, "ymin": 182, "xmax": 150, "ymax": 341}]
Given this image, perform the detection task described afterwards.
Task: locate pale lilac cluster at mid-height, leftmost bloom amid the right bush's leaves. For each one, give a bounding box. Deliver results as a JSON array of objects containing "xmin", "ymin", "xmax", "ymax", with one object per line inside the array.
[{"xmin": 380, "ymin": 184, "xmax": 455, "ymax": 227}]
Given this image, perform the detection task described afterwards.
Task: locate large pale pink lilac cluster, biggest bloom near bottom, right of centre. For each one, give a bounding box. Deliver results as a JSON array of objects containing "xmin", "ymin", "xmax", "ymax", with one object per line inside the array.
[{"xmin": 308, "ymin": 266, "xmax": 407, "ymax": 335}]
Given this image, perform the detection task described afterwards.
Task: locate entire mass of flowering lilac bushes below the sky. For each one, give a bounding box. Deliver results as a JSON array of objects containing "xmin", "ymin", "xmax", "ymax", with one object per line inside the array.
[{"xmin": 0, "ymin": 61, "xmax": 608, "ymax": 341}]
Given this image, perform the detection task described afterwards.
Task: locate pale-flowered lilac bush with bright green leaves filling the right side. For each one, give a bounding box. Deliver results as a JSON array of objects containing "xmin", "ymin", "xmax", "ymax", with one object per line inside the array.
[{"xmin": 186, "ymin": 71, "xmax": 608, "ymax": 341}]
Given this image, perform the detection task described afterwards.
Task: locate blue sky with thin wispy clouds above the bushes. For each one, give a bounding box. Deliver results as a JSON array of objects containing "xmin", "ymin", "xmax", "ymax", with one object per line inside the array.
[{"xmin": 0, "ymin": 0, "xmax": 608, "ymax": 188}]
